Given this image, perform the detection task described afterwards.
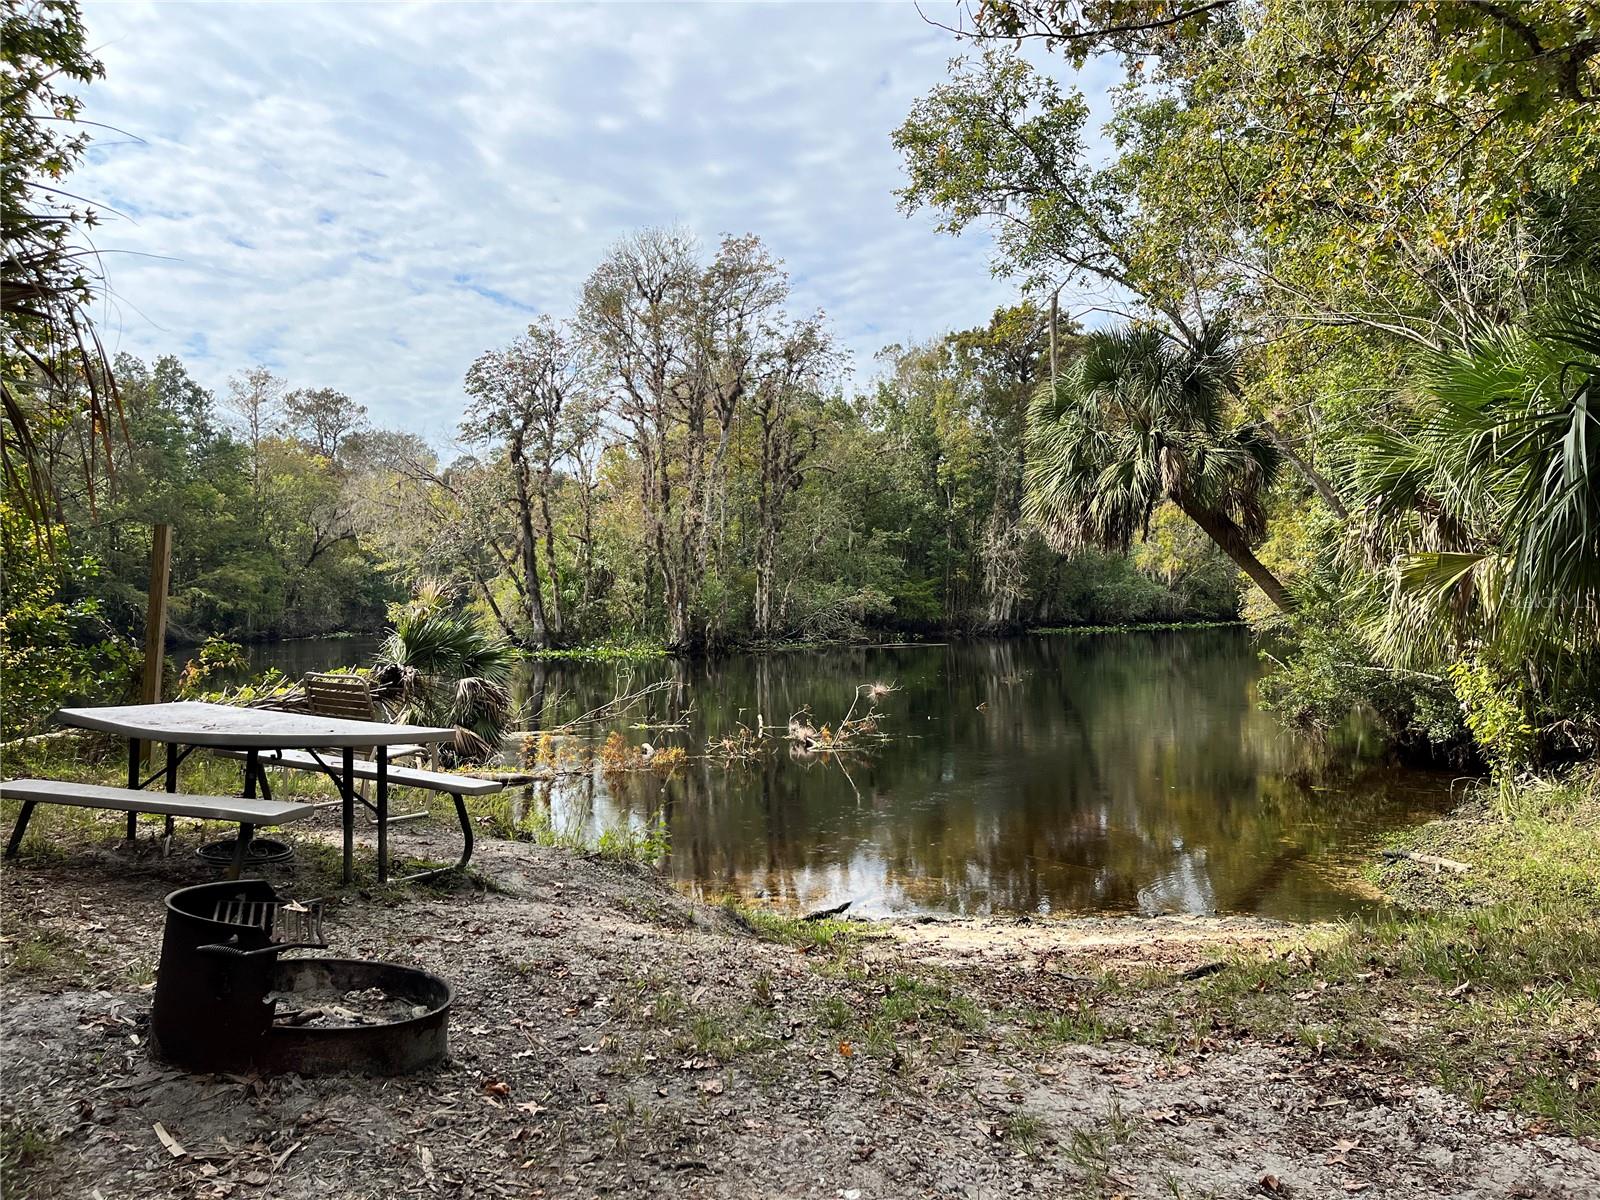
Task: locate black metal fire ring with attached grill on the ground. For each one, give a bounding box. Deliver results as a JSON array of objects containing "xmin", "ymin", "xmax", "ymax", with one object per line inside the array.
[{"xmin": 150, "ymin": 880, "xmax": 453, "ymax": 1075}]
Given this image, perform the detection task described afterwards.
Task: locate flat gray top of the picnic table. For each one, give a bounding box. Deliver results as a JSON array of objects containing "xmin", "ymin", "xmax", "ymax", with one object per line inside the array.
[{"xmin": 56, "ymin": 701, "xmax": 456, "ymax": 750}]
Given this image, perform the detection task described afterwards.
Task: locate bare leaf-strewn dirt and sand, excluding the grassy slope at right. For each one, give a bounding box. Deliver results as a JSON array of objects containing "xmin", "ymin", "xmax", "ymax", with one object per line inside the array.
[{"xmin": 0, "ymin": 824, "xmax": 1600, "ymax": 1200}]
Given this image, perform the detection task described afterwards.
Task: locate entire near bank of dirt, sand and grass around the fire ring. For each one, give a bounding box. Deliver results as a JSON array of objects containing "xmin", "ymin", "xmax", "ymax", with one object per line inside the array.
[{"xmin": 0, "ymin": 764, "xmax": 1600, "ymax": 1200}]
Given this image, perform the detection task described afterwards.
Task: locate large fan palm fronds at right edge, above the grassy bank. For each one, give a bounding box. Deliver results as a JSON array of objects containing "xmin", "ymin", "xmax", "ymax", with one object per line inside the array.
[{"xmin": 1355, "ymin": 294, "xmax": 1600, "ymax": 674}]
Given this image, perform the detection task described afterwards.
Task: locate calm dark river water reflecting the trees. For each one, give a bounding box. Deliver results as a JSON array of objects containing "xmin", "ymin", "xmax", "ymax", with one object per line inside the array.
[{"xmin": 246, "ymin": 629, "xmax": 1448, "ymax": 920}]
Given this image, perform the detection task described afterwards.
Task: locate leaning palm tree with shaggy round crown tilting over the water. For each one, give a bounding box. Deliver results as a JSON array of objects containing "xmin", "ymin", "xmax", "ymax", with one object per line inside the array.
[{"xmin": 1027, "ymin": 326, "xmax": 1296, "ymax": 613}]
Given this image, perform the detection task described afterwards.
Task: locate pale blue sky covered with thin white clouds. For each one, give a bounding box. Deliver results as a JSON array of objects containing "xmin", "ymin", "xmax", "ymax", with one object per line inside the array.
[{"xmin": 74, "ymin": 0, "xmax": 1109, "ymax": 443}]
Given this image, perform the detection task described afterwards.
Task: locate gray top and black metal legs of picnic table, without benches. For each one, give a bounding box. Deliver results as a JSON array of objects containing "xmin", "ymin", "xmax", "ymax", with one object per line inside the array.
[{"xmin": 50, "ymin": 701, "xmax": 460, "ymax": 883}]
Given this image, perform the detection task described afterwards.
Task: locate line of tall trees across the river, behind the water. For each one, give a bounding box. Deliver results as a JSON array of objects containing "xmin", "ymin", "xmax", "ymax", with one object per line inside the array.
[{"xmin": 6, "ymin": 252, "xmax": 1238, "ymax": 662}]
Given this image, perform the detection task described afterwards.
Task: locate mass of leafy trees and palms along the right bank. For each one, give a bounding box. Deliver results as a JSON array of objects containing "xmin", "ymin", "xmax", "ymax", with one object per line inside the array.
[{"xmin": 894, "ymin": 0, "xmax": 1600, "ymax": 779}]
